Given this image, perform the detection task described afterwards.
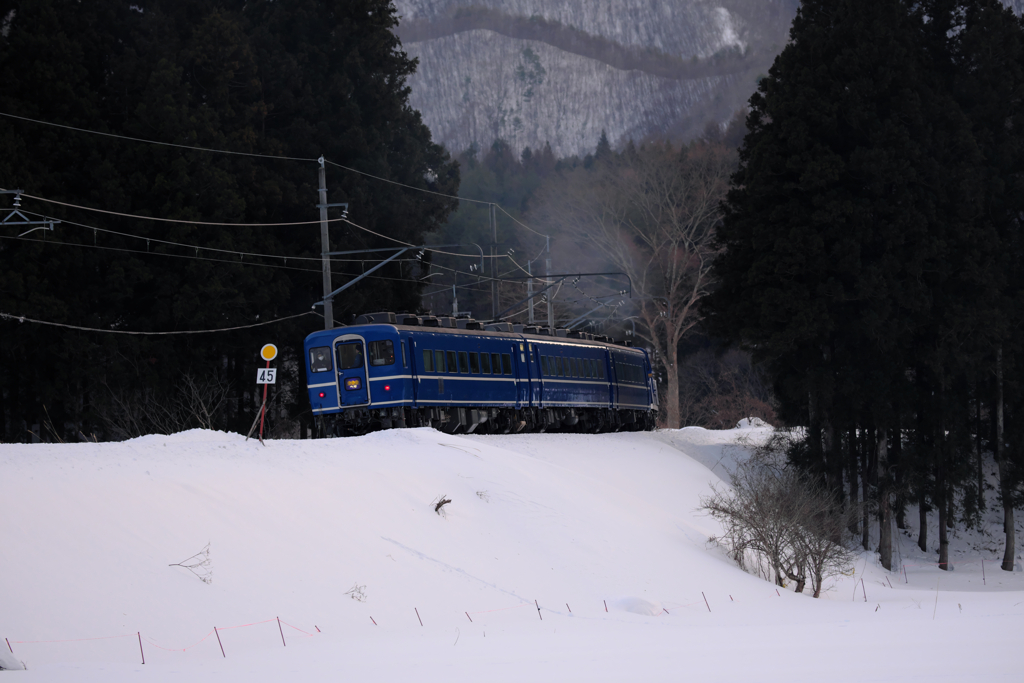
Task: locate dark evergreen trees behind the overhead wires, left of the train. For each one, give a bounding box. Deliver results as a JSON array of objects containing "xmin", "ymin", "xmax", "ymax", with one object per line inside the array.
[{"xmin": 0, "ymin": 0, "xmax": 459, "ymax": 440}]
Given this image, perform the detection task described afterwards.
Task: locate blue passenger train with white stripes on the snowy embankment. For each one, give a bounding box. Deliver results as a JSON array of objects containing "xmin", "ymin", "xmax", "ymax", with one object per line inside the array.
[{"xmin": 304, "ymin": 312, "xmax": 657, "ymax": 436}]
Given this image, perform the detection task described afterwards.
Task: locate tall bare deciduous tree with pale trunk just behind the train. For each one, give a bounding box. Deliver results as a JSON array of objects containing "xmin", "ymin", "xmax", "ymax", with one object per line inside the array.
[{"xmin": 537, "ymin": 143, "xmax": 734, "ymax": 427}]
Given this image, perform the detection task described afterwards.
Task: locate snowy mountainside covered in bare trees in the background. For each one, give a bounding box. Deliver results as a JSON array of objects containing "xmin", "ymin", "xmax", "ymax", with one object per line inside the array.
[{"xmin": 395, "ymin": 0, "xmax": 797, "ymax": 156}]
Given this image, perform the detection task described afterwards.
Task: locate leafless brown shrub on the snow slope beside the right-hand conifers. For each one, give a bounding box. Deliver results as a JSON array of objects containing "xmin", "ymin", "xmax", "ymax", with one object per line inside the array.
[{"xmin": 700, "ymin": 457, "xmax": 860, "ymax": 598}]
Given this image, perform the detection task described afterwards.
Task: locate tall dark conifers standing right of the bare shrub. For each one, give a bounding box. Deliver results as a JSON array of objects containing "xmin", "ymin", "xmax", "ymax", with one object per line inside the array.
[{"xmin": 706, "ymin": 0, "xmax": 1024, "ymax": 570}]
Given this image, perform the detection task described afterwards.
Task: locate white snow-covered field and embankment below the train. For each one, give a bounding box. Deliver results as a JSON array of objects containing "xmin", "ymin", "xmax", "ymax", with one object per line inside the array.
[{"xmin": 0, "ymin": 428, "xmax": 1024, "ymax": 683}]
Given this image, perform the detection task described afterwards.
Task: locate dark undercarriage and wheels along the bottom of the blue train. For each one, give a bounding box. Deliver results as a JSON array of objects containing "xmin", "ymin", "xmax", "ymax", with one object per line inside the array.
[{"xmin": 313, "ymin": 405, "xmax": 656, "ymax": 438}]
